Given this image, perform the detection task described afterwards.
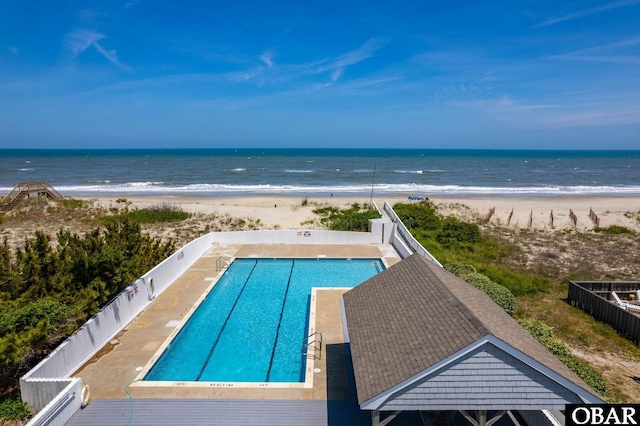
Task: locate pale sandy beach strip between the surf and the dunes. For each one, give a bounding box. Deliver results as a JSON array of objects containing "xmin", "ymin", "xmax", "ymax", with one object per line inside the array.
[{"xmin": 83, "ymin": 195, "xmax": 640, "ymax": 231}]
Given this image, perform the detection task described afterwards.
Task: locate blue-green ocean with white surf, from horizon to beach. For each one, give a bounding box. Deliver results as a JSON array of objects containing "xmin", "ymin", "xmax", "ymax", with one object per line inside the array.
[{"xmin": 0, "ymin": 149, "xmax": 640, "ymax": 197}]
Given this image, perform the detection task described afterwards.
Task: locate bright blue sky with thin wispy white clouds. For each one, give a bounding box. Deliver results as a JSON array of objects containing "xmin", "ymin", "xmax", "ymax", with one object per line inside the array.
[{"xmin": 0, "ymin": 0, "xmax": 640, "ymax": 149}]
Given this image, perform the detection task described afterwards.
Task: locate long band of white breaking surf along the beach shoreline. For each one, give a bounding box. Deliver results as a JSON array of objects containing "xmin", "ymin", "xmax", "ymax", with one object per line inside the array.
[{"xmin": 6, "ymin": 182, "xmax": 640, "ymax": 196}]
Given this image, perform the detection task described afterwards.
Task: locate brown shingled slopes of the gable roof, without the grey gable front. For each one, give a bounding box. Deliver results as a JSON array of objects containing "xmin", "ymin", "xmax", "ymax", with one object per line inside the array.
[{"xmin": 343, "ymin": 254, "xmax": 601, "ymax": 408}]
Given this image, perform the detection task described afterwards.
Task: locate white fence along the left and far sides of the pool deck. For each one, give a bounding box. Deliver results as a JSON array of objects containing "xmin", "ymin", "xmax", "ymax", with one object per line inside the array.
[{"xmin": 20, "ymin": 219, "xmax": 391, "ymax": 425}]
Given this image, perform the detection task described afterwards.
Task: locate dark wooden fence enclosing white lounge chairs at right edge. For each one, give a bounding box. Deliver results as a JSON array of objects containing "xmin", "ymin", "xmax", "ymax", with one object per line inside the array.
[{"xmin": 567, "ymin": 281, "xmax": 640, "ymax": 345}]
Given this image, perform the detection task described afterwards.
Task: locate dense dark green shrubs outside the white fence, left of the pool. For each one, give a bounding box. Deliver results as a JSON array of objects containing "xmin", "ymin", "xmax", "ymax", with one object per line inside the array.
[{"xmin": 0, "ymin": 218, "xmax": 174, "ymax": 400}]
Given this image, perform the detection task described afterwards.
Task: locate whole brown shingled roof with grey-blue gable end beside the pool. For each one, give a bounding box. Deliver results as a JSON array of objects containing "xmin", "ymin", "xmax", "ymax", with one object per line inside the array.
[{"xmin": 344, "ymin": 254, "xmax": 602, "ymax": 410}]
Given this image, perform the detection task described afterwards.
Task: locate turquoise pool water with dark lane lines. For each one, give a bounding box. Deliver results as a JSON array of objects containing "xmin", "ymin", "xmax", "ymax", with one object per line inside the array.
[{"xmin": 144, "ymin": 259, "xmax": 384, "ymax": 382}]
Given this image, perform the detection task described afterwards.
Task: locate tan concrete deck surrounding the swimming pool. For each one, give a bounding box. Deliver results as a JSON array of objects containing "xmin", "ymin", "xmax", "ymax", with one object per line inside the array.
[{"xmin": 74, "ymin": 244, "xmax": 400, "ymax": 400}]
